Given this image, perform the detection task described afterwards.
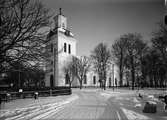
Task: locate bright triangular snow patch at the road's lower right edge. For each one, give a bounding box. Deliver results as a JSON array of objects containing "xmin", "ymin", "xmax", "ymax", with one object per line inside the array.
[{"xmin": 121, "ymin": 107, "xmax": 150, "ymax": 120}]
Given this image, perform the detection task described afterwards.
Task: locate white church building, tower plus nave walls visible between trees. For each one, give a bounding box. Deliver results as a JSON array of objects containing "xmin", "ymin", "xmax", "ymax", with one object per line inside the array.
[{"xmin": 45, "ymin": 8, "xmax": 119, "ymax": 87}]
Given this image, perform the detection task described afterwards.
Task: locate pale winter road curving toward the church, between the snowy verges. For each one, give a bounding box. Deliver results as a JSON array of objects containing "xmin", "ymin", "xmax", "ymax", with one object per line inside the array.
[{"xmin": 46, "ymin": 91, "xmax": 125, "ymax": 120}]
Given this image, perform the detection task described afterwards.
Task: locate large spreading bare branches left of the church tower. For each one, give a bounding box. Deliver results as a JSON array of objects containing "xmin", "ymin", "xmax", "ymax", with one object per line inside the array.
[{"xmin": 0, "ymin": 0, "xmax": 50, "ymax": 73}]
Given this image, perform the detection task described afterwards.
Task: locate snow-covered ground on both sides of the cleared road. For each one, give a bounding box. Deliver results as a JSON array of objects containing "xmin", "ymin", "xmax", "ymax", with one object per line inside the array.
[{"xmin": 0, "ymin": 89, "xmax": 165, "ymax": 120}]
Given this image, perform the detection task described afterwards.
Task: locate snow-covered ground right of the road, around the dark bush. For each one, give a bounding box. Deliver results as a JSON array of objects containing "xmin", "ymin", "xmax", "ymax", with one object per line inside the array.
[{"xmin": 100, "ymin": 89, "xmax": 167, "ymax": 120}]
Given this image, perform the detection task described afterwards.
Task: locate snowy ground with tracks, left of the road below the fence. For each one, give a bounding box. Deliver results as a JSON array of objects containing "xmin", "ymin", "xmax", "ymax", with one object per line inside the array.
[{"xmin": 0, "ymin": 94, "xmax": 78, "ymax": 120}]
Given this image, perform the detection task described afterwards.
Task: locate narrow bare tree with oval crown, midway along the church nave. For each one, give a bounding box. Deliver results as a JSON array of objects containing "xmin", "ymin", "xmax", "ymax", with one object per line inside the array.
[{"xmin": 91, "ymin": 43, "xmax": 111, "ymax": 89}]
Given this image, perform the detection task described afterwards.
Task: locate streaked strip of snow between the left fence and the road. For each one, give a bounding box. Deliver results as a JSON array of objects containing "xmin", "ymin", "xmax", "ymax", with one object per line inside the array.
[{"xmin": 0, "ymin": 95, "xmax": 79, "ymax": 120}]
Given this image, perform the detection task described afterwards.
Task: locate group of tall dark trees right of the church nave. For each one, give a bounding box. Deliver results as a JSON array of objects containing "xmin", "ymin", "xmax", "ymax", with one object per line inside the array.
[{"xmin": 112, "ymin": 24, "xmax": 167, "ymax": 89}]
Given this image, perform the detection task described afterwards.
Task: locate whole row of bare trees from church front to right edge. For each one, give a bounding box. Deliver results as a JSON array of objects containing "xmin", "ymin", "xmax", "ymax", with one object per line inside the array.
[{"xmin": 65, "ymin": 24, "xmax": 167, "ymax": 89}]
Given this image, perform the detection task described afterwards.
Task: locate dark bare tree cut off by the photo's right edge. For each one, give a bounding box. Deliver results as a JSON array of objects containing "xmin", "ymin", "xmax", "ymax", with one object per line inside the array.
[{"xmin": 152, "ymin": 23, "xmax": 167, "ymax": 87}]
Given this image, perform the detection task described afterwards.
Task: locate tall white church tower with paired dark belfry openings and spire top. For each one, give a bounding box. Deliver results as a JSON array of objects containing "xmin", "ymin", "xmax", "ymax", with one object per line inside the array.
[{"xmin": 45, "ymin": 8, "xmax": 76, "ymax": 87}]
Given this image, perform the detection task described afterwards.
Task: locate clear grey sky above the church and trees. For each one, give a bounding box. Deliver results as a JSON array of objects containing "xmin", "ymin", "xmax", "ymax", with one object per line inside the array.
[{"xmin": 42, "ymin": 0, "xmax": 165, "ymax": 56}]
